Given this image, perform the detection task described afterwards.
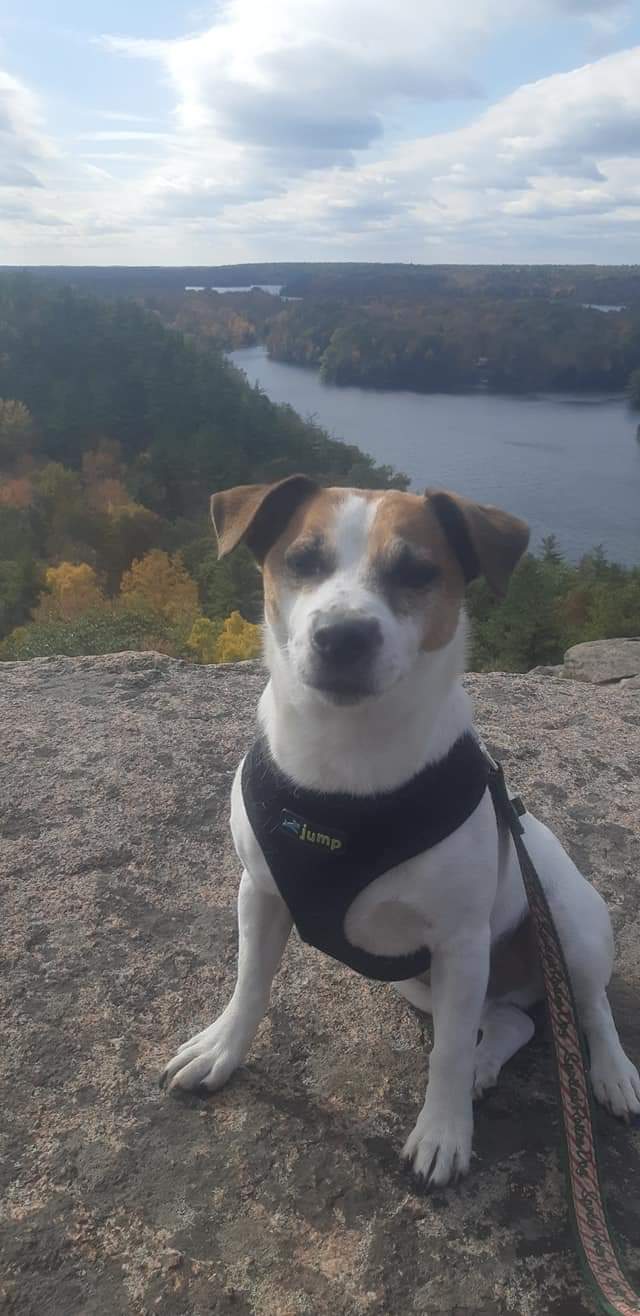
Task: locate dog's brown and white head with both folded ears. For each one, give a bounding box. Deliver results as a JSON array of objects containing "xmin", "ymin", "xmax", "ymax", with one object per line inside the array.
[{"xmin": 211, "ymin": 475, "xmax": 528, "ymax": 704}]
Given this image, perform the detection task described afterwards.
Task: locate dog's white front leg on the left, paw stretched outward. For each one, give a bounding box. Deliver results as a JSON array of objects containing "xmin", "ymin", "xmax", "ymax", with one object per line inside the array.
[{"xmin": 161, "ymin": 869, "xmax": 291, "ymax": 1092}]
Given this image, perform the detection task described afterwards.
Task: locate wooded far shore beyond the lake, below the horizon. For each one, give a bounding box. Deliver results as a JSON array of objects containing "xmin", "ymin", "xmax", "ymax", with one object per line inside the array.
[{"xmin": 145, "ymin": 290, "xmax": 640, "ymax": 393}]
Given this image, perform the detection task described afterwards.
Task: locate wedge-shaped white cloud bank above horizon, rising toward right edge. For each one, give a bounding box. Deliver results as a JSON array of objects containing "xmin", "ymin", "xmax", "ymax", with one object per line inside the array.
[{"xmin": 213, "ymin": 47, "xmax": 640, "ymax": 259}]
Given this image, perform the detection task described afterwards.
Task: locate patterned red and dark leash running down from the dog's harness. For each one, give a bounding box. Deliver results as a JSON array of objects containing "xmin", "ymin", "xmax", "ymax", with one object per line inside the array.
[{"xmin": 485, "ymin": 750, "xmax": 640, "ymax": 1316}]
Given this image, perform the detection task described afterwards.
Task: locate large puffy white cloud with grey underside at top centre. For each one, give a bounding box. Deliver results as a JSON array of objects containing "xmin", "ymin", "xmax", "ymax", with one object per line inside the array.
[{"xmin": 104, "ymin": 0, "xmax": 521, "ymax": 185}]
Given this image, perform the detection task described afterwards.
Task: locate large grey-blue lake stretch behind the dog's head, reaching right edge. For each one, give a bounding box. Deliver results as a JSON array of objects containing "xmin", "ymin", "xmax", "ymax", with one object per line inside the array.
[{"xmin": 230, "ymin": 347, "xmax": 640, "ymax": 565}]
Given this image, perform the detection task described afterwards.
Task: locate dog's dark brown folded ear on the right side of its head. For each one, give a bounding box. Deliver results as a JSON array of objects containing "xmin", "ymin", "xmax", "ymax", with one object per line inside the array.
[{"xmin": 424, "ymin": 490, "xmax": 529, "ymax": 597}]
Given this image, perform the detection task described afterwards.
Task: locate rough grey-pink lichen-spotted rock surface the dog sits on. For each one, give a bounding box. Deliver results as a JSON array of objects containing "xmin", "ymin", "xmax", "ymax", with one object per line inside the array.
[{"xmin": 0, "ymin": 654, "xmax": 640, "ymax": 1316}]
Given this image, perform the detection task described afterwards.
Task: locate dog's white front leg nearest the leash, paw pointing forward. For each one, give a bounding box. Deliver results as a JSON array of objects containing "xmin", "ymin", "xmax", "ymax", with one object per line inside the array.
[{"xmin": 403, "ymin": 928, "xmax": 490, "ymax": 1186}]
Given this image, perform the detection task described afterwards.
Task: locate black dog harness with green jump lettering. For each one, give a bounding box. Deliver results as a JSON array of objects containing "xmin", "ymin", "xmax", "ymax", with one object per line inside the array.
[{"xmin": 242, "ymin": 733, "xmax": 490, "ymax": 982}]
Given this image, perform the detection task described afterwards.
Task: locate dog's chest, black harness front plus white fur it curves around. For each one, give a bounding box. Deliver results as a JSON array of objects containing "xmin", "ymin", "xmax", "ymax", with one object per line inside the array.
[{"xmin": 237, "ymin": 736, "xmax": 495, "ymax": 980}]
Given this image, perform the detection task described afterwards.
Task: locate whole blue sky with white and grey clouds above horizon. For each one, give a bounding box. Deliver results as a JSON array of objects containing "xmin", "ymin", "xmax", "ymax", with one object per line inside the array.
[{"xmin": 0, "ymin": 0, "xmax": 640, "ymax": 265}]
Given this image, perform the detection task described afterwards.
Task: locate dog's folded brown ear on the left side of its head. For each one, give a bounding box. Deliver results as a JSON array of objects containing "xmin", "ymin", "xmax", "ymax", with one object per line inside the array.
[{"xmin": 211, "ymin": 475, "xmax": 319, "ymax": 563}]
